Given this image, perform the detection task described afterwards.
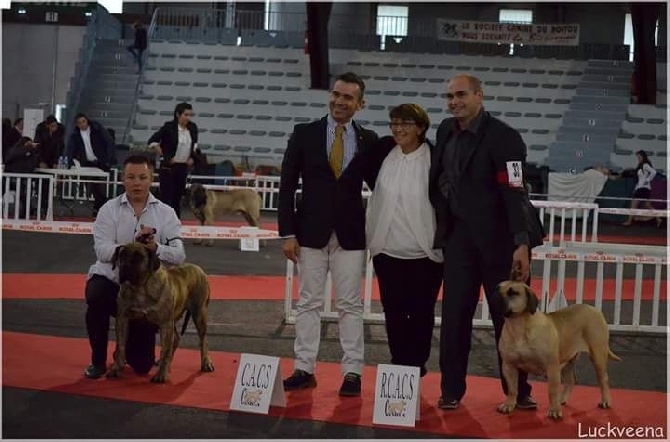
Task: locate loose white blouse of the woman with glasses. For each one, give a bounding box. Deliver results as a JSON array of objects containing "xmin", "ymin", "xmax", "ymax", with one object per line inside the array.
[{"xmin": 366, "ymin": 143, "xmax": 444, "ymax": 262}]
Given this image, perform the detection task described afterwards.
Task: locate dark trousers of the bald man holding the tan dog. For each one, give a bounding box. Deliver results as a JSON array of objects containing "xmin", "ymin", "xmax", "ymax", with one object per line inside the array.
[{"xmin": 440, "ymin": 221, "xmax": 531, "ymax": 400}]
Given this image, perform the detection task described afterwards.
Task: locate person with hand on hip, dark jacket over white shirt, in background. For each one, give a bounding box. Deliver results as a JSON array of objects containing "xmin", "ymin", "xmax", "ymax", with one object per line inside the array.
[{"xmin": 147, "ymin": 103, "xmax": 198, "ymax": 218}]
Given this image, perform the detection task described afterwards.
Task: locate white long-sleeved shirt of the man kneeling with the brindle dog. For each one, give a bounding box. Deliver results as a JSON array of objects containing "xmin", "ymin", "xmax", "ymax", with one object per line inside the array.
[{"xmin": 88, "ymin": 193, "xmax": 186, "ymax": 284}]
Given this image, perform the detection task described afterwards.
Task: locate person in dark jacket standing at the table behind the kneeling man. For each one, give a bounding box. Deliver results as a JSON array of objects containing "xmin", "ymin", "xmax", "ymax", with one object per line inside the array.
[{"xmin": 66, "ymin": 113, "xmax": 114, "ymax": 214}]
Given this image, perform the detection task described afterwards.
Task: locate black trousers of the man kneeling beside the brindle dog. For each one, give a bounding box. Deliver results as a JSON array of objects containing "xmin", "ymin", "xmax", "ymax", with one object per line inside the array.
[{"xmin": 86, "ymin": 275, "xmax": 157, "ymax": 375}]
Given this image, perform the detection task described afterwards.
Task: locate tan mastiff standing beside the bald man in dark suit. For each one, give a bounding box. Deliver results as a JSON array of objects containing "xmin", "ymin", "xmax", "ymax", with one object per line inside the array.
[{"xmin": 496, "ymin": 280, "xmax": 620, "ymax": 419}]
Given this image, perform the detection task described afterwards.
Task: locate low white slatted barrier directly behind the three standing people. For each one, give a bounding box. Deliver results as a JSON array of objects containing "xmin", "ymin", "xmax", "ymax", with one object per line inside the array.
[{"xmin": 284, "ymin": 242, "xmax": 667, "ymax": 333}]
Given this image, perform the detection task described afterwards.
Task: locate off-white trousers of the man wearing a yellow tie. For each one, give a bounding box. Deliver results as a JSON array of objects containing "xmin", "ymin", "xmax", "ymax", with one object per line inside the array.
[{"xmin": 294, "ymin": 232, "xmax": 365, "ymax": 374}]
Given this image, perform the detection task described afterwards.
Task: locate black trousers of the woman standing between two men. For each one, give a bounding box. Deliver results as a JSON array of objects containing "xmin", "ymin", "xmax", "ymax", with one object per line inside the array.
[{"xmin": 372, "ymin": 253, "xmax": 442, "ymax": 376}]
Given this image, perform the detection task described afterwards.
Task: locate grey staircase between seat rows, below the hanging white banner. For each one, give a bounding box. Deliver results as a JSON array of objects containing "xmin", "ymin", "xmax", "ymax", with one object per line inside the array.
[{"xmin": 547, "ymin": 60, "xmax": 633, "ymax": 173}]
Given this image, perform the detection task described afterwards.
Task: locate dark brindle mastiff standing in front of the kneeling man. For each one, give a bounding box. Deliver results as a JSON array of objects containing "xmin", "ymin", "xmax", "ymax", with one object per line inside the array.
[{"xmin": 107, "ymin": 242, "xmax": 214, "ymax": 383}]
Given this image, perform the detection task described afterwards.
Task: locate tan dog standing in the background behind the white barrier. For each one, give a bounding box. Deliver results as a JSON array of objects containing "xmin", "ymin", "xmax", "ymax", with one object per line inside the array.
[{"xmin": 190, "ymin": 183, "xmax": 261, "ymax": 246}]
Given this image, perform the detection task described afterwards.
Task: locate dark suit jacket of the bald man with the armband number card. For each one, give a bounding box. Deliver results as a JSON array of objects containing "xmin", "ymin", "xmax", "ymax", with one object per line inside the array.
[{"xmin": 430, "ymin": 112, "xmax": 528, "ymax": 253}]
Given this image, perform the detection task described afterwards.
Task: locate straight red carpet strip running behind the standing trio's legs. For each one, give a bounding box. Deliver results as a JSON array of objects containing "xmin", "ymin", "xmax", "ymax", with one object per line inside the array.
[{"xmin": 2, "ymin": 273, "xmax": 668, "ymax": 301}]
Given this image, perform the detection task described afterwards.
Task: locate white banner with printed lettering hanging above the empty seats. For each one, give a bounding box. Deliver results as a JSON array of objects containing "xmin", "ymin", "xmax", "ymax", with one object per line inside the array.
[{"xmin": 437, "ymin": 18, "xmax": 579, "ymax": 46}]
